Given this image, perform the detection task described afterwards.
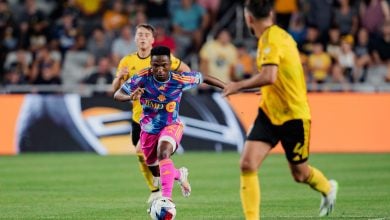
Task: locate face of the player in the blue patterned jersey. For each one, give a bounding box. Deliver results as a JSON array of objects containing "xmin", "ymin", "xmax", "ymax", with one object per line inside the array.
[{"xmin": 150, "ymin": 55, "xmax": 171, "ymax": 82}]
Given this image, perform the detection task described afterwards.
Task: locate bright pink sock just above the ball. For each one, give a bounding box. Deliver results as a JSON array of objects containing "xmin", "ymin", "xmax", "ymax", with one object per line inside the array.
[{"xmin": 159, "ymin": 159, "xmax": 180, "ymax": 198}]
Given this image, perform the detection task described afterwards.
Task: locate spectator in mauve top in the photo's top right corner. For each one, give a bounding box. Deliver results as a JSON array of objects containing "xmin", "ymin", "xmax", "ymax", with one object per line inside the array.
[{"xmin": 359, "ymin": 0, "xmax": 390, "ymax": 37}]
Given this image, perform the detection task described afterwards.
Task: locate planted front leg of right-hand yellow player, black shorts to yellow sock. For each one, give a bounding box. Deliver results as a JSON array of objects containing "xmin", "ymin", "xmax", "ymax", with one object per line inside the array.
[{"xmin": 240, "ymin": 109, "xmax": 278, "ymax": 220}]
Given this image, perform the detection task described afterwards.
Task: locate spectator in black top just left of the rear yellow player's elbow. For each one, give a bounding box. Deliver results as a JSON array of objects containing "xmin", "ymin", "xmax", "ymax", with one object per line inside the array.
[{"xmin": 83, "ymin": 57, "xmax": 114, "ymax": 96}]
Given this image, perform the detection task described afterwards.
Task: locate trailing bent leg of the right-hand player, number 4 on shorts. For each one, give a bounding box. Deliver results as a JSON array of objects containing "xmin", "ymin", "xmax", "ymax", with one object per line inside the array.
[{"xmin": 281, "ymin": 120, "xmax": 337, "ymax": 216}]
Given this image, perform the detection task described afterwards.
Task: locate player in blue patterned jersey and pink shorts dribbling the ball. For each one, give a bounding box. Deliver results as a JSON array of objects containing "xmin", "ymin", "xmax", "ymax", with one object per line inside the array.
[{"xmin": 114, "ymin": 46, "xmax": 225, "ymax": 199}]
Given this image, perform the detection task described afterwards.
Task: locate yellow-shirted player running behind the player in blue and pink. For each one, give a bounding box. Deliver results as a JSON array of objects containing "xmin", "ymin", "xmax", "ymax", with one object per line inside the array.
[{"xmin": 112, "ymin": 24, "xmax": 190, "ymax": 203}]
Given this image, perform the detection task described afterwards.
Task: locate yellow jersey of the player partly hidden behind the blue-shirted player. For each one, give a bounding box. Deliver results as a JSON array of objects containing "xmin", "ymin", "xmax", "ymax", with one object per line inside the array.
[{"xmin": 116, "ymin": 52, "xmax": 181, "ymax": 123}]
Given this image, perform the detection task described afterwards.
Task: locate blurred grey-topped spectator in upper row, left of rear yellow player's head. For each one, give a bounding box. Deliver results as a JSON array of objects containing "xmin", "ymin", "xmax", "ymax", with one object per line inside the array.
[{"xmin": 87, "ymin": 27, "xmax": 113, "ymax": 60}]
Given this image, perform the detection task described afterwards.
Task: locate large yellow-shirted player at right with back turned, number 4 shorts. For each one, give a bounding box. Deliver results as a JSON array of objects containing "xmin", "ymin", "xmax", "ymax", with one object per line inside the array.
[{"xmin": 224, "ymin": 0, "xmax": 338, "ymax": 220}]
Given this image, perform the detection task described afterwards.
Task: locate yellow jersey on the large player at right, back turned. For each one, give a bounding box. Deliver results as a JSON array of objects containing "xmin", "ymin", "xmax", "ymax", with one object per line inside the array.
[{"xmin": 256, "ymin": 25, "xmax": 311, "ymax": 125}]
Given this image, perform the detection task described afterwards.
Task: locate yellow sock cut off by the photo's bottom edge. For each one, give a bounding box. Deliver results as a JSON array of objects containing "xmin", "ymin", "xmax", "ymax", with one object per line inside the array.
[{"xmin": 240, "ymin": 172, "xmax": 260, "ymax": 220}]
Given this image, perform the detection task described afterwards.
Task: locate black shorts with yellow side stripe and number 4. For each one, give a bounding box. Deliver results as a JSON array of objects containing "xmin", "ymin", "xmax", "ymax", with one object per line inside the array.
[{"xmin": 247, "ymin": 108, "xmax": 310, "ymax": 164}]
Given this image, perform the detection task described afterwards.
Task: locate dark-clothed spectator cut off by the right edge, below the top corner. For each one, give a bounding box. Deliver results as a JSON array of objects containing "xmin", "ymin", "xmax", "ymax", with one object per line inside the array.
[{"xmin": 373, "ymin": 20, "xmax": 390, "ymax": 82}]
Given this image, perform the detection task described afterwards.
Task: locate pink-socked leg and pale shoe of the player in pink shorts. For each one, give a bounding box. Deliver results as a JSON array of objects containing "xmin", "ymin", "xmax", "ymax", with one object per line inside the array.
[{"xmin": 157, "ymin": 124, "xmax": 191, "ymax": 198}]
